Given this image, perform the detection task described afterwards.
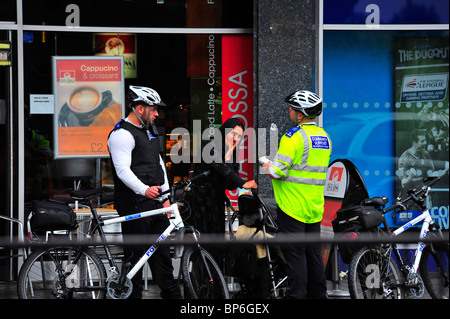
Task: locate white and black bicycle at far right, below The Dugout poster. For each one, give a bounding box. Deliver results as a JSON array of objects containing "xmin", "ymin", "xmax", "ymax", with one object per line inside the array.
[{"xmin": 348, "ymin": 177, "xmax": 449, "ymax": 299}]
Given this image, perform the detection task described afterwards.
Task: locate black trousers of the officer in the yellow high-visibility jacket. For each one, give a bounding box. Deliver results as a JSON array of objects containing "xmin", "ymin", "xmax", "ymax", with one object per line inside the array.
[{"xmin": 277, "ymin": 207, "xmax": 327, "ymax": 299}]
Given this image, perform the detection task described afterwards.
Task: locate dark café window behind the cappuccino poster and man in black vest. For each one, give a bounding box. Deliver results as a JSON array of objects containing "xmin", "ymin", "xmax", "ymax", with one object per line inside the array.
[{"xmin": 24, "ymin": 0, "xmax": 253, "ymax": 206}]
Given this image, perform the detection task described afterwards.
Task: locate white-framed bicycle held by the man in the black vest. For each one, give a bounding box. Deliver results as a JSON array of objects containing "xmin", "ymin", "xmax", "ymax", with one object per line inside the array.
[{"xmin": 17, "ymin": 172, "xmax": 229, "ymax": 299}]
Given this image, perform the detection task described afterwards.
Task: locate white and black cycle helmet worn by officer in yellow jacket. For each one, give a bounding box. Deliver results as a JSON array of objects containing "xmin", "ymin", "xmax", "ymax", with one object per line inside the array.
[{"xmin": 284, "ymin": 91, "xmax": 322, "ymax": 119}]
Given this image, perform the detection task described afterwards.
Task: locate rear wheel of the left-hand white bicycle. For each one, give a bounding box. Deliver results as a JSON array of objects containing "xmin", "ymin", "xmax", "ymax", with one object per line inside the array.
[{"xmin": 17, "ymin": 247, "xmax": 107, "ymax": 299}]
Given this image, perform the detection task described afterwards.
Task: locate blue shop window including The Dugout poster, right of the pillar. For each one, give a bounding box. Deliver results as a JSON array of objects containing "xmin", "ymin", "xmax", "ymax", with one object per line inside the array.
[{"xmin": 323, "ymin": 31, "xmax": 449, "ymax": 225}]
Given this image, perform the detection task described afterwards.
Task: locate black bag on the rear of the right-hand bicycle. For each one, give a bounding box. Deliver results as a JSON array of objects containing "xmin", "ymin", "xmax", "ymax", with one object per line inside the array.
[{"xmin": 332, "ymin": 206, "xmax": 384, "ymax": 264}]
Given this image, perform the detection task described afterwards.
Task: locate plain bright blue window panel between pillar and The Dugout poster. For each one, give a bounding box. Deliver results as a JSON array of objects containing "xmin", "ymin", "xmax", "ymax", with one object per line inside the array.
[{"xmin": 323, "ymin": 31, "xmax": 395, "ymax": 220}]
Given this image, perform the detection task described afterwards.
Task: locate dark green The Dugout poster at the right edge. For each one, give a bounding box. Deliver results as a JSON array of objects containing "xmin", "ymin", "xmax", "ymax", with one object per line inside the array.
[{"xmin": 395, "ymin": 37, "xmax": 449, "ymax": 229}]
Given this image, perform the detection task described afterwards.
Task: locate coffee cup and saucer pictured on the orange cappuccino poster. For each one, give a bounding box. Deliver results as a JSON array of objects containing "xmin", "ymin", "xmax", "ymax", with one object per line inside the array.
[{"xmin": 58, "ymin": 86, "xmax": 113, "ymax": 127}]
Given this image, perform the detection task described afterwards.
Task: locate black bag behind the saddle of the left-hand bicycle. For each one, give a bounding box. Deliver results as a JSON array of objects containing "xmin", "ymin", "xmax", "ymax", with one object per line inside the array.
[{"xmin": 30, "ymin": 200, "xmax": 78, "ymax": 232}]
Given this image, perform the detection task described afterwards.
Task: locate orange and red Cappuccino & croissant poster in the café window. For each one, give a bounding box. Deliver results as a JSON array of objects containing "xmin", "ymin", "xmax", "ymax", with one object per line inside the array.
[{"xmin": 53, "ymin": 57, "xmax": 125, "ymax": 158}]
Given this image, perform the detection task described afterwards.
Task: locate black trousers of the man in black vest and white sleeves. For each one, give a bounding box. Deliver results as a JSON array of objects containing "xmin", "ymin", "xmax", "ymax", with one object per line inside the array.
[{"xmin": 114, "ymin": 195, "xmax": 181, "ymax": 299}]
